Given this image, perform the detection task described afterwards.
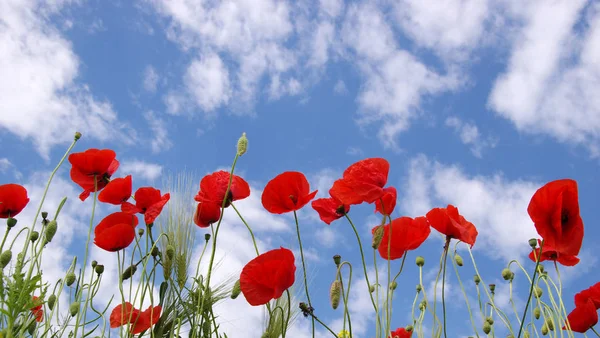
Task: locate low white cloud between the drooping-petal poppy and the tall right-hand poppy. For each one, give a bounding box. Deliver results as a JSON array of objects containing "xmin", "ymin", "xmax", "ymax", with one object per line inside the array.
[{"xmin": 400, "ymin": 156, "xmax": 541, "ymax": 260}]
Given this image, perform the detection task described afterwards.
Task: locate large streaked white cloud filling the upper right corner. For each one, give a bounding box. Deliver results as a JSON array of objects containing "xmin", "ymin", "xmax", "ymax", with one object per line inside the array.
[{"xmin": 489, "ymin": 0, "xmax": 600, "ymax": 155}]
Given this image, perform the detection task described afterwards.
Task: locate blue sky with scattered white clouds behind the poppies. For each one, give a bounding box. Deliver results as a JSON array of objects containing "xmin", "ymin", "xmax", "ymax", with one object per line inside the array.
[{"xmin": 0, "ymin": 0, "xmax": 600, "ymax": 337}]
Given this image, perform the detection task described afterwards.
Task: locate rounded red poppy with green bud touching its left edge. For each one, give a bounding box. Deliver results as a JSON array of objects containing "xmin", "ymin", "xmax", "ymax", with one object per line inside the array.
[{"xmin": 371, "ymin": 217, "xmax": 431, "ymax": 260}]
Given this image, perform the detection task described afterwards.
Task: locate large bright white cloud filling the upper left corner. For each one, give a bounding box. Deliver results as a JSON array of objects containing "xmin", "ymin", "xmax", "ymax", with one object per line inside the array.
[{"xmin": 0, "ymin": 0, "xmax": 136, "ymax": 159}]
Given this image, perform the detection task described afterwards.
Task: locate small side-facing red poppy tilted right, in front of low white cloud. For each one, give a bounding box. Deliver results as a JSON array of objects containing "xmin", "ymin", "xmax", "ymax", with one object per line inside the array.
[{"xmin": 426, "ymin": 204, "xmax": 477, "ymax": 247}]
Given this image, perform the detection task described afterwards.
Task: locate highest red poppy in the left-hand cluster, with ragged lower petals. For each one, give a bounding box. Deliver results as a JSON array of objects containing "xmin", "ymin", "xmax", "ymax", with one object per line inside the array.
[{"xmin": 69, "ymin": 149, "xmax": 119, "ymax": 201}]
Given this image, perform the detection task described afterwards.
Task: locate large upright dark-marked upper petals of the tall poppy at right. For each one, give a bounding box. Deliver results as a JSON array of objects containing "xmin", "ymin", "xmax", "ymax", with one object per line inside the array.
[{"xmin": 527, "ymin": 179, "xmax": 583, "ymax": 256}]
